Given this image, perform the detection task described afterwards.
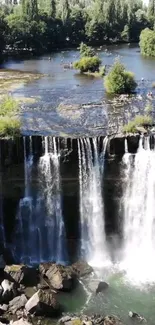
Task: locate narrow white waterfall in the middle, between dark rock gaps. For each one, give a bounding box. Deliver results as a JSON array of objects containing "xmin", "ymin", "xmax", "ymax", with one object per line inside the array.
[{"xmin": 78, "ymin": 138, "xmax": 109, "ymax": 267}]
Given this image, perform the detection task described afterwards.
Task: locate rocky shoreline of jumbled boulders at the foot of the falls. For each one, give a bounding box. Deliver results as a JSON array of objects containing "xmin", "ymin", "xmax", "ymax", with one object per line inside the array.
[{"xmin": 0, "ymin": 258, "xmax": 145, "ymax": 325}]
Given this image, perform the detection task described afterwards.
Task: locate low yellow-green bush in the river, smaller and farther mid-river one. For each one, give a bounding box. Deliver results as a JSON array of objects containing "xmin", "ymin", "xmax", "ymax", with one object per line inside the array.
[{"xmin": 73, "ymin": 56, "xmax": 101, "ymax": 73}]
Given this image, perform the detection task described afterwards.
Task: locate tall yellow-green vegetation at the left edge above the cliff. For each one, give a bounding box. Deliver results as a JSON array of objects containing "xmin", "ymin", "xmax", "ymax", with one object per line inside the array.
[{"xmin": 0, "ymin": 96, "xmax": 20, "ymax": 137}]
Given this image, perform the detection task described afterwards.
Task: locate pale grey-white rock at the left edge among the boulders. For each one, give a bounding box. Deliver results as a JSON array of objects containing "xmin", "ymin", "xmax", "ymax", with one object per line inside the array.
[{"xmin": 0, "ymin": 279, "xmax": 18, "ymax": 304}]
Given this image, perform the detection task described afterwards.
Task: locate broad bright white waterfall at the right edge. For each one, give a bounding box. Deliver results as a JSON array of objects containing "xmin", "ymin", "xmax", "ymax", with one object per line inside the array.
[{"xmin": 121, "ymin": 137, "xmax": 155, "ymax": 282}]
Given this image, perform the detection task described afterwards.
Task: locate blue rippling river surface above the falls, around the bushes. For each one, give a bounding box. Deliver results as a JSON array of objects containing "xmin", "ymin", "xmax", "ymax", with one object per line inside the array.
[{"xmin": 1, "ymin": 45, "xmax": 155, "ymax": 137}]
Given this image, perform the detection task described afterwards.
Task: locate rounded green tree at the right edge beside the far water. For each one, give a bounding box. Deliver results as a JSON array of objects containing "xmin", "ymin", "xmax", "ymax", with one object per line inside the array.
[{"xmin": 139, "ymin": 28, "xmax": 155, "ymax": 57}]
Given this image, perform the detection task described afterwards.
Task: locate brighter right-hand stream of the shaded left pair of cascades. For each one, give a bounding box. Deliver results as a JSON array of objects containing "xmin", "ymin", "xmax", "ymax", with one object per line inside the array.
[{"xmin": 38, "ymin": 137, "xmax": 67, "ymax": 263}]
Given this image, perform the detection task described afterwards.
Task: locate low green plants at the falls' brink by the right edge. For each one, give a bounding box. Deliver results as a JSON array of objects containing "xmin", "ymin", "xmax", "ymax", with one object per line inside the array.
[{"xmin": 123, "ymin": 115, "xmax": 153, "ymax": 133}]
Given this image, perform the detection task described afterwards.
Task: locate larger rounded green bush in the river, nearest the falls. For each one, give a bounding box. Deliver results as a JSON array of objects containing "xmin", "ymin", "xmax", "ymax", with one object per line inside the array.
[{"xmin": 104, "ymin": 61, "xmax": 137, "ymax": 94}]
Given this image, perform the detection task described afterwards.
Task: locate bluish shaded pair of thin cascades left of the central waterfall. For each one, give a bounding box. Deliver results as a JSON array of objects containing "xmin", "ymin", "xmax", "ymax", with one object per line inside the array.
[{"xmin": 13, "ymin": 137, "xmax": 67, "ymax": 264}]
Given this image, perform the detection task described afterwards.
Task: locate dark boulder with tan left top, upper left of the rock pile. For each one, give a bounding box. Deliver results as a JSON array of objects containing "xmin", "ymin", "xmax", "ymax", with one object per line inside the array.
[{"xmin": 4, "ymin": 265, "xmax": 38, "ymax": 287}]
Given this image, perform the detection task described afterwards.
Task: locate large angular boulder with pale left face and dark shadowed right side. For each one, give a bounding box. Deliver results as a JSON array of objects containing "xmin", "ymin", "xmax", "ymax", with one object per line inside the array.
[{"xmin": 25, "ymin": 290, "xmax": 60, "ymax": 316}]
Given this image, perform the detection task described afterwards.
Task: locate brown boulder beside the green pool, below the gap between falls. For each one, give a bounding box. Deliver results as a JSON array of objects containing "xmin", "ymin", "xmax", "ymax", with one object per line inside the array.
[{"xmin": 39, "ymin": 263, "xmax": 74, "ymax": 291}]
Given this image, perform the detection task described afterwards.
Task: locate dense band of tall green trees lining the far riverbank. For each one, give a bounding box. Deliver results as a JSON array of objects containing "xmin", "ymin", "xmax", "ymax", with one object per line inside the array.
[{"xmin": 0, "ymin": 0, "xmax": 154, "ymax": 57}]
